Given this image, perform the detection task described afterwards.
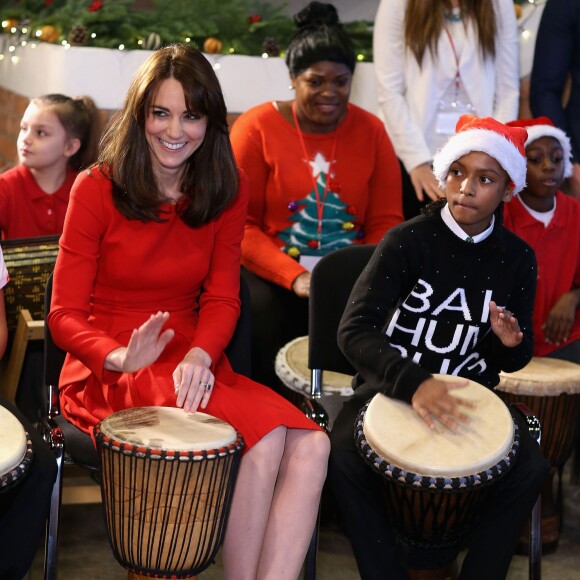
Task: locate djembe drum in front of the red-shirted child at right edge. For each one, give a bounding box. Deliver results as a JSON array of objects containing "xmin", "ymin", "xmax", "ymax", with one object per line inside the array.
[{"xmin": 496, "ymin": 357, "xmax": 580, "ymax": 553}]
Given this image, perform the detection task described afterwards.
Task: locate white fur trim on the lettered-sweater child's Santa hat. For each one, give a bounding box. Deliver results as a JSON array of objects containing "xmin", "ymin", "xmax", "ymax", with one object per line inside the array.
[{"xmin": 433, "ymin": 129, "xmax": 526, "ymax": 194}]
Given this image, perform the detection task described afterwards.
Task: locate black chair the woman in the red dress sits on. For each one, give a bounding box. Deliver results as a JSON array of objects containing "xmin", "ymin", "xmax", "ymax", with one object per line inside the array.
[{"xmin": 39, "ymin": 274, "xmax": 251, "ymax": 580}]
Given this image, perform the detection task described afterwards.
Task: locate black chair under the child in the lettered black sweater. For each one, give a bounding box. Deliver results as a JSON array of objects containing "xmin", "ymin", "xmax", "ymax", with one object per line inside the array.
[{"xmin": 304, "ymin": 246, "xmax": 542, "ymax": 580}]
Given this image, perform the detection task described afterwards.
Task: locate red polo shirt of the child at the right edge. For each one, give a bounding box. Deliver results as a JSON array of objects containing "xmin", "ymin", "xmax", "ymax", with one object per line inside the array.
[{"xmin": 504, "ymin": 191, "xmax": 580, "ymax": 356}]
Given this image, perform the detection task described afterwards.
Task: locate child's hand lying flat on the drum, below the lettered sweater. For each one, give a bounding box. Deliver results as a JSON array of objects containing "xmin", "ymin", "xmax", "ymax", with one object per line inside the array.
[{"xmin": 411, "ymin": 377, "xmax": 474, "ymax": 430}]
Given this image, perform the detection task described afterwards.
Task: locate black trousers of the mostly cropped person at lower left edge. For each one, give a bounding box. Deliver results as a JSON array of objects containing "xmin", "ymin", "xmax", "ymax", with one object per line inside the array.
[{"xmin": 0, "ymin": 398, "xmax": 56, "ymax": 580}]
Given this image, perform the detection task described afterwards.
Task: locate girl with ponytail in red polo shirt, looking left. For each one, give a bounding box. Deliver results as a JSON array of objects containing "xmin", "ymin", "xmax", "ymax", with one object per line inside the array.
[{"xmin": 0, "ymin": 94, "xmax": 100, "ymax": 239}]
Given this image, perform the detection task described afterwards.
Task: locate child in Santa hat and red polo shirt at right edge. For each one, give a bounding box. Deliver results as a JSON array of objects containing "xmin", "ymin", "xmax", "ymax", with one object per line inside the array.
[{"xmin": 504, "ymin": 117, "xmax": 580, "ymax": 363}]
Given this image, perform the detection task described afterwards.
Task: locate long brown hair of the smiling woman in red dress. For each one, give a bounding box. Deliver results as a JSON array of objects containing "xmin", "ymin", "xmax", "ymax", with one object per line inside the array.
[{"xmin": 99, "ymin": 44, "xmax": 239, "ymax": 227}]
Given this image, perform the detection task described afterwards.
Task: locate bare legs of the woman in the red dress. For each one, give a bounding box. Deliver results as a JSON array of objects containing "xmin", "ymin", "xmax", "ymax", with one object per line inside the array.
[{"xmin": 222, "ymin": 427, "xmax": 330, "ymax": 580}]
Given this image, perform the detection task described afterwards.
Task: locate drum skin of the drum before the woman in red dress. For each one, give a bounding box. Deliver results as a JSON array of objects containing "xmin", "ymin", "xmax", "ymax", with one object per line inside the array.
[{"xmin": 100, "ymin": 407, "xmax": 237, "ymax": 452}]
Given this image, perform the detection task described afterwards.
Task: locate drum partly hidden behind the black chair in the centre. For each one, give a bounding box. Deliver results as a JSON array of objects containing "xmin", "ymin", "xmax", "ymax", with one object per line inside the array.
[{"xmin": 275, "ymin": 336, "xmax": 353, "ymax": 397}]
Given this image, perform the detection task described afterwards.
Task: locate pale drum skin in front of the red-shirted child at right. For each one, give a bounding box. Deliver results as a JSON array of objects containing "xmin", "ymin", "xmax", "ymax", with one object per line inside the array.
[{"xmin": 496, "ymin": 356, "xmax": 580, "ymax": 397}]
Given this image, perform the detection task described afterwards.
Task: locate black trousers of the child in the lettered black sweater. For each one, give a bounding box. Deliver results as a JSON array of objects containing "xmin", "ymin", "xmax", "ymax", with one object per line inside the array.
[{"xmin": 328, "ymin": 385, "xmax": 550, "ymax": 580}]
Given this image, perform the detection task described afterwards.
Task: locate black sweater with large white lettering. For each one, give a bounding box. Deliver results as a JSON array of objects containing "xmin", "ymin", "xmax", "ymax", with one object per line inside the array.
[{"xmin": 338, "ymin": 211, "xmax": 536, "ymax": 402}]
